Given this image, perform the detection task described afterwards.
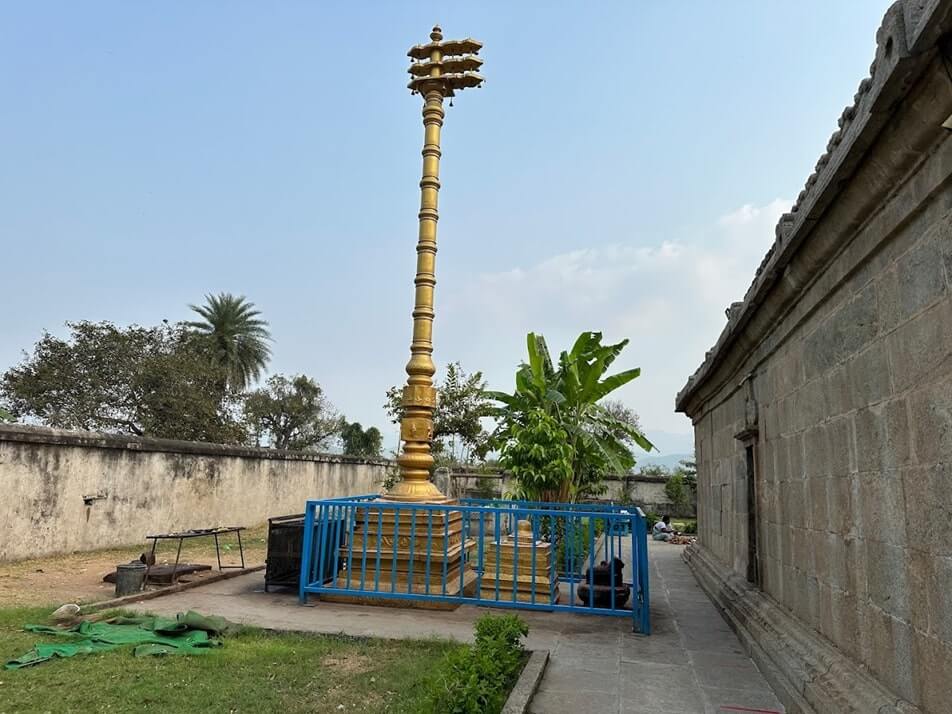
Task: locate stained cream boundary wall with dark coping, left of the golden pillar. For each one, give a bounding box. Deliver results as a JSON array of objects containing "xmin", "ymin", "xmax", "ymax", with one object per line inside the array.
[{"xmin": 0, "ymin": 425, "xmax": 389, "ymax": 562}]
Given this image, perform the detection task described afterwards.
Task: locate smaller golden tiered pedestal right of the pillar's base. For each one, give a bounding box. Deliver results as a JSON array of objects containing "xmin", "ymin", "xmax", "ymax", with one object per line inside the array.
[{"xmin": 480, "ymin": 521, "xmax": 559, "ymax": 605}]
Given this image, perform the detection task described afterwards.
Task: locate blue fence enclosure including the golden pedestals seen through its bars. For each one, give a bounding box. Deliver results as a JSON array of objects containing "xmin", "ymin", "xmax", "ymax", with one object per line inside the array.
[{"xmin": 299, "ymin": 494, "xmax": 651, "ymax": 634}]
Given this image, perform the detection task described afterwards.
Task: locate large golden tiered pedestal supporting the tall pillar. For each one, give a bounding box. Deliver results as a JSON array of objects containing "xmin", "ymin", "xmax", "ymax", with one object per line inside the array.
[{"xmin": 321, "ymin": 505, "xmax": 476, "ymax": 610}]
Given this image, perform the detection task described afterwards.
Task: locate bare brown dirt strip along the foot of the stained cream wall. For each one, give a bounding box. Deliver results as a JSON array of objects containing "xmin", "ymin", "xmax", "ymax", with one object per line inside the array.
[{"xmin": 0, "ymin": 524, "xmax": 268, "ymax": 607}]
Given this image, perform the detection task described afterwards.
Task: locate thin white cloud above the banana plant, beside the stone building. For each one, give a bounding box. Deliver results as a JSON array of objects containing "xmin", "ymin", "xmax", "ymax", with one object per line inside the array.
[{"xmin": 441, "ymin": 199, "xmax": 790, "ymax": 435}]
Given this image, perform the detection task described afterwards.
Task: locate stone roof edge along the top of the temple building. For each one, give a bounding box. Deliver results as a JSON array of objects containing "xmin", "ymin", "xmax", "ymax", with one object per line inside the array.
[{"xmin": 675, "ymin": 0, "xmax": 952, "ymax": 411}]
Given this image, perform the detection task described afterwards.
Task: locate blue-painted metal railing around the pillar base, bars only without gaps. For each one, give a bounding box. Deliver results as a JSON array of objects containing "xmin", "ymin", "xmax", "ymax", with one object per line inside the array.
[{"xmin": 298, "ymin": 496, "xmax": 650, "ymax": 634}]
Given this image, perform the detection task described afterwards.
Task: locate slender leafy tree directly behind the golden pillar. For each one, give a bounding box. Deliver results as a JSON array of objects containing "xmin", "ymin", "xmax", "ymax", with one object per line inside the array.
[{"xmin": 384, "ymin": 362, "xmax": 492, "ymax": 464}]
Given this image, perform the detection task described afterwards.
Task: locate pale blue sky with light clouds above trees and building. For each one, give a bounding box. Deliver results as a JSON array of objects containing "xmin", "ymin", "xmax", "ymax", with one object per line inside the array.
[{"xmin": 0, "ymin": 0, "xmax": 889, "ymax": 453}]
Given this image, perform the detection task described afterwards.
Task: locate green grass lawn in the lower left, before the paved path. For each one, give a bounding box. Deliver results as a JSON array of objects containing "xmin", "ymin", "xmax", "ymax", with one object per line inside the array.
[{"xmin": 0, "ymin": 608, "xmax": 460, "ymax": 714}]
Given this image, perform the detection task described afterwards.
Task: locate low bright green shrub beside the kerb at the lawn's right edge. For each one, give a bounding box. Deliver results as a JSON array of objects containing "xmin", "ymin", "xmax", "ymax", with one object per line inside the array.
[{"xmin": 424, "ymin": 615, "xmax": 529, "ymax": 714}]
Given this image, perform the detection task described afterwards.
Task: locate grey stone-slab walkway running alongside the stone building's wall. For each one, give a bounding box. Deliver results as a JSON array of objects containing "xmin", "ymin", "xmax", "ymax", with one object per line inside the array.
[{"xmin": 532, "ymin": 543, "xmax": 783, "ymax": 714}]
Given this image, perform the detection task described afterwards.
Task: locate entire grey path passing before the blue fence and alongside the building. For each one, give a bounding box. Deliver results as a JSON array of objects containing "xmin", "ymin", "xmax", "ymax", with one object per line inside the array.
[{"xmin": 126, "ymin": 543, "xmax": 783, "ymax": 714}]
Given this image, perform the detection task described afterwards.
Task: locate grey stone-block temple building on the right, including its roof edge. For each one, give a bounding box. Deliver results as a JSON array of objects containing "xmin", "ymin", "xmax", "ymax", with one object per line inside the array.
[{"xmin": 677, "ymin": 0, "xmax": 952, "ymax": 714}]
